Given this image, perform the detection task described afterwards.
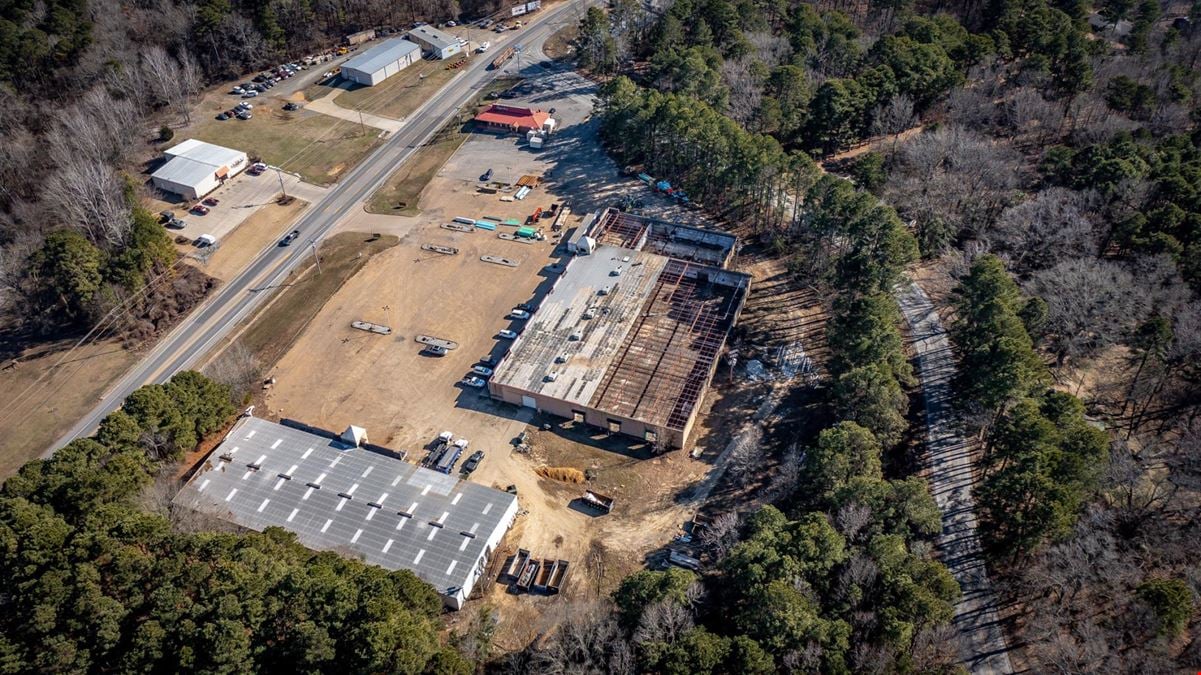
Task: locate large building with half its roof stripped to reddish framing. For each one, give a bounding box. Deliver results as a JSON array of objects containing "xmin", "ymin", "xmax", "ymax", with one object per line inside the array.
[{"xmin": 489, "ymin": 209, "xmax": 751, "ymax": 447}]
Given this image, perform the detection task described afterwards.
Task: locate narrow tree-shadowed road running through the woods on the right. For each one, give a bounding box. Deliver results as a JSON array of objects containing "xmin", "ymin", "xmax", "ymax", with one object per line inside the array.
[{"xmin": 897, "ymin": 281, "xmax": 1014, "ymax": 674}]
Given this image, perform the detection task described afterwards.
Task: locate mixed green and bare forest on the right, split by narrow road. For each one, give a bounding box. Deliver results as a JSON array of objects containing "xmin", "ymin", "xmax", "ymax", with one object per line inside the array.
[{"xmin": 547, "ymin": 0, "xmax": 1201, "ymax": 673}]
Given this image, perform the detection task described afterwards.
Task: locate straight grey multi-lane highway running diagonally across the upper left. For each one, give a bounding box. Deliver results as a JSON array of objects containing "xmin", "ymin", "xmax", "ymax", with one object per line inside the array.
[{"xmin": 42, "ymin": 0, "xmax": 594, "ymax": 458}]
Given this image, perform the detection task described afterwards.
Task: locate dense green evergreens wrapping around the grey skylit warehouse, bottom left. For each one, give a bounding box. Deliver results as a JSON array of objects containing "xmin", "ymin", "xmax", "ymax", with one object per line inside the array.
[{"xmin": 0, "ymin": 372, "xmax": 473, "ymax": 674}]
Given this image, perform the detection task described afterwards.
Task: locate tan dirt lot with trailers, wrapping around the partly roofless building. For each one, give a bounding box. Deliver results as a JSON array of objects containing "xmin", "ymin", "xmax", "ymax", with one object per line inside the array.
[{"xmin": 236, "ymin": 56, "xmax": 754, "ymax": 634}]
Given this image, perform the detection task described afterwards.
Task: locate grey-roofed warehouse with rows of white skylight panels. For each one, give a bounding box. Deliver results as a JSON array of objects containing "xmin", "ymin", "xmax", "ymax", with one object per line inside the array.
[{"xmin": 174, "ymin": 417, "xmax": 518, "ymax": 609}]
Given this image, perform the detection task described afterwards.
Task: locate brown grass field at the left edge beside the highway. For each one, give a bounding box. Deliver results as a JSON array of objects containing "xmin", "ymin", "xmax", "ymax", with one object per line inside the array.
[{"xmin": 0, "ymin": 340, "xmax": 137, "ymax": 480}]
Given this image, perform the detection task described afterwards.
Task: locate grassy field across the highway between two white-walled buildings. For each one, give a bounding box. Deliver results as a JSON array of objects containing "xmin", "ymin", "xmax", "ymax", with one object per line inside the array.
[{"xmin": 175, "ymin": 90, "xmax": 380, "ymax": 185}]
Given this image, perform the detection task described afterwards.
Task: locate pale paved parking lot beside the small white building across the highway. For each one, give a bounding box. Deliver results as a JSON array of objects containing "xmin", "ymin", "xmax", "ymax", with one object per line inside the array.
[{"xmin": 169, "ymin": 171, "xmax": 325, "ymax": 241}]
